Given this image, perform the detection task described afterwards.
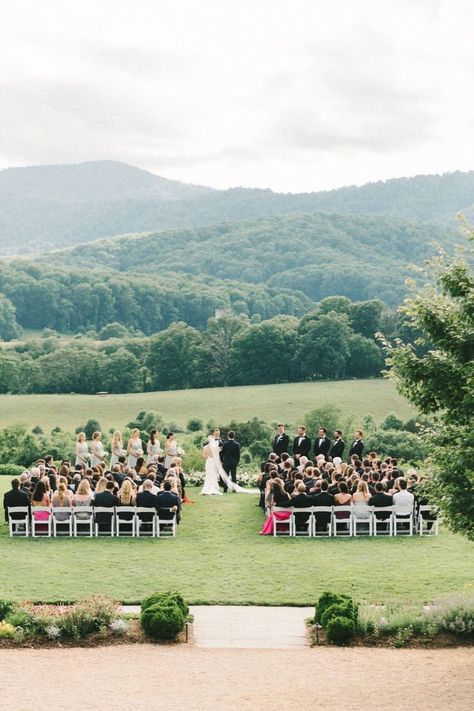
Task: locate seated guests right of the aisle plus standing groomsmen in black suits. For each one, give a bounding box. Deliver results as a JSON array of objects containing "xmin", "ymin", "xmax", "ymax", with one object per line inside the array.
[{"xmin": 258, "ymin": 425, "xmax": 428, "ymax": 535}]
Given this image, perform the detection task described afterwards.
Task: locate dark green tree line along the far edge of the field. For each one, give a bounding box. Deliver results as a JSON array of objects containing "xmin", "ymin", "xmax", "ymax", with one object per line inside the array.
[{"xmin": 0, "ymin": 297, "xmax": 393, "ymax": 394}]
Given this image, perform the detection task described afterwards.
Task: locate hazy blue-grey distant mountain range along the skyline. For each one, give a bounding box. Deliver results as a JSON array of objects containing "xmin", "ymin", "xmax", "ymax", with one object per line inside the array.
[{"xmin": 0, "ymin": 161, "xmax": 474, "ymax": 254}]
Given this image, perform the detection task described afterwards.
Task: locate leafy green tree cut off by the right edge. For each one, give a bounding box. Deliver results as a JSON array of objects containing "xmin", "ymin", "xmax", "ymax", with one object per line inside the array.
[{"xmin": 386, "ymin": 230, "xmax": 474, "ymax": 539}]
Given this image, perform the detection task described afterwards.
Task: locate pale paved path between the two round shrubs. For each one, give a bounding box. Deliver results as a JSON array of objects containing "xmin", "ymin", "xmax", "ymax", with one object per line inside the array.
[{"xmin": 124, "ymin": 605, "xmax": 314, "ymax": 649}]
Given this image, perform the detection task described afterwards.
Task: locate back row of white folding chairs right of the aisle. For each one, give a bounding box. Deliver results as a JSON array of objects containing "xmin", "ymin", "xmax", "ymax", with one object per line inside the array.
[{"xmin": 272, "ymin": 505, "xmax": 439, "ymax": 538}]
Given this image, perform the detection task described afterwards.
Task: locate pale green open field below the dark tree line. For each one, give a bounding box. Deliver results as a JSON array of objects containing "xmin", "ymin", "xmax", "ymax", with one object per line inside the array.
[{"xmin": 0, "ymin": 379, "xmax": 414, "ymax": 431}]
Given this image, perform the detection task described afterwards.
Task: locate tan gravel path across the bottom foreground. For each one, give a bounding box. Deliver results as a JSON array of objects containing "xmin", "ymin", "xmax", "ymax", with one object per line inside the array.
[{"xmin": 0, "ymin": 644, "xmax": 474, "ymax": 711}]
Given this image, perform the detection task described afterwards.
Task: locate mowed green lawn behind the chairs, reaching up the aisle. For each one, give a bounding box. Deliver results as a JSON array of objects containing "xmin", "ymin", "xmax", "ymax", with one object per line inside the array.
[{"xmin": 0, "ymin": 478, "xmax": 474, "ymax": 605}]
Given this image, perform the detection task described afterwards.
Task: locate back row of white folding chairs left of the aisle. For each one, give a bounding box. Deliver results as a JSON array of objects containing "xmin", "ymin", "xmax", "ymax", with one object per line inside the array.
[{"xmin": 8, "ymin": 506, "xmax": 177, "ymax": 538}]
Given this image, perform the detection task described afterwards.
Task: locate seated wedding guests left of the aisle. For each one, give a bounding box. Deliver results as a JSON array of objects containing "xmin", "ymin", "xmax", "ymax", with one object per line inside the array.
[{"xmin": 3, "ymin": 442, "xmax": 188, "ymax": 523}]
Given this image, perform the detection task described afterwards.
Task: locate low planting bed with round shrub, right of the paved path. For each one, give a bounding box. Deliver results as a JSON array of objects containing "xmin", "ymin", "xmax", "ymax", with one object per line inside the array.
[{"xmin": 312, "ymin": 589, "xmax": 474, "ymax": 647}]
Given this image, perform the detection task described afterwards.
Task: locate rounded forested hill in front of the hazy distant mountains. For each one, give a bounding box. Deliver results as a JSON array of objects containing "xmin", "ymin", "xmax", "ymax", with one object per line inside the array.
[{"xmin": 44, "ymin": 213, "xmax": 457, "ymax": 304}]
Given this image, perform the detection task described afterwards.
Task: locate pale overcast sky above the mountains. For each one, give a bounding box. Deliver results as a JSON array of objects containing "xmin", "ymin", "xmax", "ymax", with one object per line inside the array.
[{"xmin": 0, "ymin": 0, "xmax": 474, "ymax": 192}]
